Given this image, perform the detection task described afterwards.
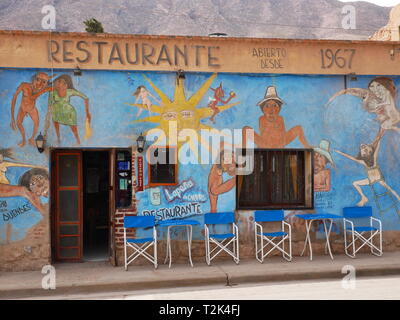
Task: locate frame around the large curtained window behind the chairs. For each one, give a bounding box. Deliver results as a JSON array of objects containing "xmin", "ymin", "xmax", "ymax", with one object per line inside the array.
[{"xmin": 235, "ymin": 148, "xmax": 315, "ymax": 211}]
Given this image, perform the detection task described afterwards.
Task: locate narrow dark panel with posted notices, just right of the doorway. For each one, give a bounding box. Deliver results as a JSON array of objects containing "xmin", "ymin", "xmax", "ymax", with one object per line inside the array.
[{"xmin": 115, "ymin": 150, "xmax": 132, "ymax": 209}]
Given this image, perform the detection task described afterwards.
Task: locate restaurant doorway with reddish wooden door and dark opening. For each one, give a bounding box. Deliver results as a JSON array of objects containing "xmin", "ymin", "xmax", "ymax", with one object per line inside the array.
[{"xmin": 51, "ymin": 149, "xmax": 114, "ymax": 262}]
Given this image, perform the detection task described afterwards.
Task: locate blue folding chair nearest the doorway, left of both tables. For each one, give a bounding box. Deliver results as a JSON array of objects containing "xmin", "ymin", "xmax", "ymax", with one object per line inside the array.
[{"xmin": 124, "ymin": 216, "xmax": 158, "ymax": 270}]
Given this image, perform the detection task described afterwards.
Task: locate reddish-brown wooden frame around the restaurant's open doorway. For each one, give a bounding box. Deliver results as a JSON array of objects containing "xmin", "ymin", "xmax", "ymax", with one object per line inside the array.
[{"xmin": 49, "ymin": 148, "xmax": 118, "ymax": 265}]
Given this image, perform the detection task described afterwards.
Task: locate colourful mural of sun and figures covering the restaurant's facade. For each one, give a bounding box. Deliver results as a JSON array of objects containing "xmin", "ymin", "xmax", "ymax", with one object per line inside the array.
[{"xmin": 0, "ymin": 70, "xmax": 400, "ymax": 244}]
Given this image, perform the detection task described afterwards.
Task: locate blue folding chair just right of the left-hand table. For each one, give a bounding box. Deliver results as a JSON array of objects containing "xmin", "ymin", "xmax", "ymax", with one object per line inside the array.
[{"xmin": 204, "ymin": 212, "xmax": 239, "ymax": 265}]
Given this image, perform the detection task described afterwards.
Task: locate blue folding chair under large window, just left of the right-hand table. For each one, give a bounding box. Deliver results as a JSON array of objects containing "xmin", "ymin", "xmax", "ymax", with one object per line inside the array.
[{"xmin": 254, "ymin": 210, "xmax": 292, "ymax": 263}]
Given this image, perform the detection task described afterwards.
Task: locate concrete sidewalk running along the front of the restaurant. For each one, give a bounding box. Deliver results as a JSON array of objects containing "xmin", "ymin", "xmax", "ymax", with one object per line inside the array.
[{"xmin": 0, "ymin": 252, "xmax": 400, "ymax": 299}]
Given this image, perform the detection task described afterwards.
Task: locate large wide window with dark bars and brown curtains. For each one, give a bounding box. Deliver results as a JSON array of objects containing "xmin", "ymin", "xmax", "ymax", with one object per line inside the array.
[{"xmin": 236, "ymin": 149, "xmax": 314, "ymax": 210}]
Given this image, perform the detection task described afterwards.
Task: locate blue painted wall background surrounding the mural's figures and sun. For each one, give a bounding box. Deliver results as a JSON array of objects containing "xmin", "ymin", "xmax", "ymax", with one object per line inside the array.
[{"xmin": 0, "ymin": 69, "xmax": 400, "ymax": 244}]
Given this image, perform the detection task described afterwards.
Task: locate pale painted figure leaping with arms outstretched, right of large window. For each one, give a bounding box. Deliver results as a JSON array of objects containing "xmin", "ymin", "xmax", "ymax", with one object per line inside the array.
[{"xmin": 335, "ymin": 131, "xmax": 400, "ymax": 207}]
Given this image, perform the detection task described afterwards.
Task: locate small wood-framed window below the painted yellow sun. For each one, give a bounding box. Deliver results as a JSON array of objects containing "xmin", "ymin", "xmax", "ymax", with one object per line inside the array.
[{"xmin": 148, "ymin": 147, "xmax": 178, "ymax": 187}]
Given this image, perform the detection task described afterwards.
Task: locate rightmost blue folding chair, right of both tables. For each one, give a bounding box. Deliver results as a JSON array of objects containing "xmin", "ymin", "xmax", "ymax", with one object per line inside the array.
[{"xmin": 343, "ymin": 207, "xmax": 383, "ymax": 258}]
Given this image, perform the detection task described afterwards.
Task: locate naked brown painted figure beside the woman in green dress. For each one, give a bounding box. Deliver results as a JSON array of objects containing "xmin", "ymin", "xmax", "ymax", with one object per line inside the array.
[{"xmin": 11, "ymin": 72, "xmax": 52, "ymax": 147}]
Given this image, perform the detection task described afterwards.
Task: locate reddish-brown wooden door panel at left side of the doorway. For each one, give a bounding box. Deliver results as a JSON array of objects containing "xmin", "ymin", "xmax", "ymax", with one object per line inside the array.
[{"xmin": 53, "ymin": 151, "xmax": 83, "ymax": 261}]
